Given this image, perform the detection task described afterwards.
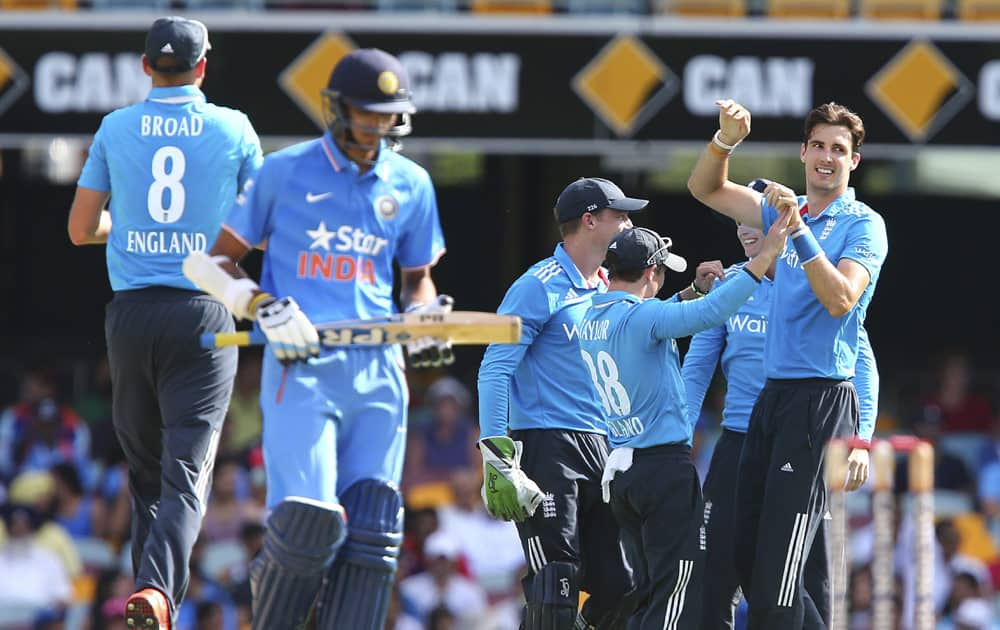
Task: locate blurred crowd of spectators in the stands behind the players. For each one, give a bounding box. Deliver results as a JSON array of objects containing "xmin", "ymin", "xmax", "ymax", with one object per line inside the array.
[{"xmin": 0, "ymin": 349, "xmax": 1000, "ymax": 630}]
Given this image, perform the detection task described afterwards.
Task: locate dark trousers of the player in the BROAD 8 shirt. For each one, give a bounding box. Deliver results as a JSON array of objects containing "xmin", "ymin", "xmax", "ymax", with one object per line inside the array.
[{"xmin": 105, "ymin": 287, "xmax": 237, "ymax": 613}]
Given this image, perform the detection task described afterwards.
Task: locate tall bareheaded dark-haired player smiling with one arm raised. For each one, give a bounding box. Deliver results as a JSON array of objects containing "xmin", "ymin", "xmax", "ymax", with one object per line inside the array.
[{"xmin": 688, "ymin": 100, "xmax": 888, "ymax": 629}]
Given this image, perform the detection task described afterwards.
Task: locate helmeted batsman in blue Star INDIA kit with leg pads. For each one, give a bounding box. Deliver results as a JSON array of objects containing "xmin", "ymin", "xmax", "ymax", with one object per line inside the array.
[{"xmin": 184, "ymin": 48, "xmax": 452, "ymax": 630}]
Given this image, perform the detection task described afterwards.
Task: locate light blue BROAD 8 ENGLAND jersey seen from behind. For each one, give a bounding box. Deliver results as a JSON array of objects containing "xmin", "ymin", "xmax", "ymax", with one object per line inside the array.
[{"xmin": 77, "ymin": 85, "xmax": 263, "ymax": 291}]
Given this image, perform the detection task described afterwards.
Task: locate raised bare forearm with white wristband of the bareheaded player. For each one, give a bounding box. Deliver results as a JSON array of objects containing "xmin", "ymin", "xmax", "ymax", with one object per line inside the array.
[{"xmin": 688, "ymin": 99, "xmax": 761, "ymax": 227}]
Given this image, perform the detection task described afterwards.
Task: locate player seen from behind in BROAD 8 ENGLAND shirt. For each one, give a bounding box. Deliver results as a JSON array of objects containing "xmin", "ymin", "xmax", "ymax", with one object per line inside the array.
[{"xmin": 69, "ymin": 17, "xmax": 262, "ymax": 628}]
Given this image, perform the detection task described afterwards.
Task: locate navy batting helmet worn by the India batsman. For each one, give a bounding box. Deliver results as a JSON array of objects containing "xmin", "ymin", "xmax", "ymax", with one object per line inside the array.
[{"xmin": 326, "ymin": 48, "xmax": 417, "ymax": 114}]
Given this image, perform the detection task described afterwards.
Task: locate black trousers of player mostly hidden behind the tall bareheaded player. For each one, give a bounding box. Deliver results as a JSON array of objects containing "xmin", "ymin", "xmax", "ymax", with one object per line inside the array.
[{"xmin": 701, "ymin": 429, "xmax": 831, "ymax": 630}]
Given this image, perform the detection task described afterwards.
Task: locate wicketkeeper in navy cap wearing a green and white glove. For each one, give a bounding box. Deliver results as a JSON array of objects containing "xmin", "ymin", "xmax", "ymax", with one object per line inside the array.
[{"xmin": 479, "ymin": 177, "xmax": 648, "ymax": 630}]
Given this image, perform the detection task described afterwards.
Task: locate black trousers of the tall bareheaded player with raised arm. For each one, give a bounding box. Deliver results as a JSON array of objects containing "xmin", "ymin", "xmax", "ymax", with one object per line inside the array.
[{"xmin": 734, "ymin": 379, "xmax": 859, "ymax": 630}]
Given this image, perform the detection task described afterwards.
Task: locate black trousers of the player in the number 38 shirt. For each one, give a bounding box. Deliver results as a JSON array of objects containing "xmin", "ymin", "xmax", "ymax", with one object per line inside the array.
[{"xmin": 611, "ymin": 444, "xmax": 706, "ymax": 630}]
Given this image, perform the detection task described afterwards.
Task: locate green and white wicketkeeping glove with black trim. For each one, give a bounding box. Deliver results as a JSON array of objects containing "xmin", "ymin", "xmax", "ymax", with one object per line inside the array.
[{"xmin": 479, "ymin": 437, "xmax": 545, "ymax": 521}]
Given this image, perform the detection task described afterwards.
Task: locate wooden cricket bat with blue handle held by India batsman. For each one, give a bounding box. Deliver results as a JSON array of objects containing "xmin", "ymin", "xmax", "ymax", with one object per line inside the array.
[{"xmin": 201, "ymin": 311, "xmax": 521, "ymax": 348}]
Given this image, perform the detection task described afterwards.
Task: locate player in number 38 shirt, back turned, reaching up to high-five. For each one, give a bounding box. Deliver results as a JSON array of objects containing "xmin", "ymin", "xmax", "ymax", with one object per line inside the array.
[{"xmin": 578, "ymin": 222, "xmax": 787, "ymax": 630}]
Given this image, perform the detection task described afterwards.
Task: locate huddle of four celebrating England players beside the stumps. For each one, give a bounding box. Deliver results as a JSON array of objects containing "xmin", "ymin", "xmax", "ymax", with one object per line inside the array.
[{"xmin": 479, "ymin": 101, "xmax": 887, "ymax": 630}]
